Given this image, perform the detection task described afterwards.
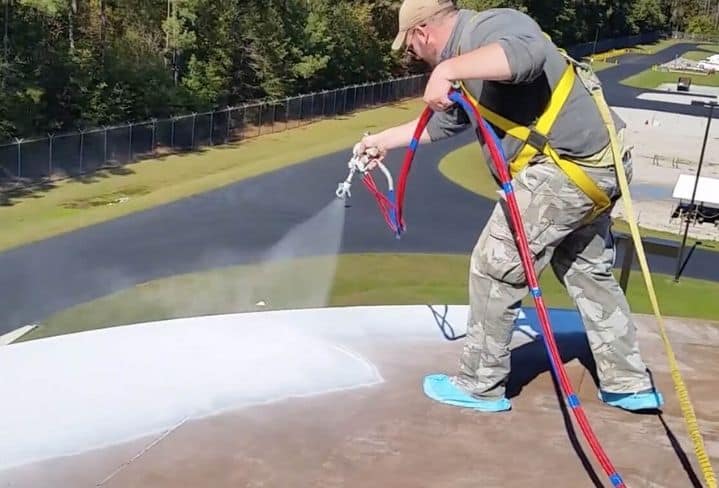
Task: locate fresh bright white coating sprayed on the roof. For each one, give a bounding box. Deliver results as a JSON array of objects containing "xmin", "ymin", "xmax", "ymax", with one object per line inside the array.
[{"xmin": 0, "ymin": 306, "xmax": 467, "ymax": 470}]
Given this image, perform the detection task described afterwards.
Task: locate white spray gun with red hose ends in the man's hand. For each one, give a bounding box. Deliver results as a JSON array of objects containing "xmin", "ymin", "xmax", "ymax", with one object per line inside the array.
[{"xmin": 335, "ymin": 134, "xmax": 400, "ymax": 238}]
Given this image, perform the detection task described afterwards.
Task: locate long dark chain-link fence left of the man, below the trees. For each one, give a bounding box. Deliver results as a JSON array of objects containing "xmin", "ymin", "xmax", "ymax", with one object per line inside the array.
[{"xmin": 0, "ymin": 74, "xmax": 428, "ymax": 184}]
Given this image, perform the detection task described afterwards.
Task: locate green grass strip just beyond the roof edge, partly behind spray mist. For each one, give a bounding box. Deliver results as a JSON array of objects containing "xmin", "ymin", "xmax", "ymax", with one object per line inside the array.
[{"xmin": 21, "ymin": 254, "xmax": 719, "ymax": 341}]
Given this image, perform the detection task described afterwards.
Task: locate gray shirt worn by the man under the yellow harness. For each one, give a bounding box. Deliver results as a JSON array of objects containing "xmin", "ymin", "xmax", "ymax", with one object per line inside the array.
[{"xmin": 427, "ymin": 8, "xmax": 623, "ymax": 175}]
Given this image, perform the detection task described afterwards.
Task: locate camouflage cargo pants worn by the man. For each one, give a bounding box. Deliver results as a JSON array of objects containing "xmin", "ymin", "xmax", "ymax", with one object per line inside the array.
[{"xmin": 454, "ymin": 156, "xmax": 651, "ymax": 398}]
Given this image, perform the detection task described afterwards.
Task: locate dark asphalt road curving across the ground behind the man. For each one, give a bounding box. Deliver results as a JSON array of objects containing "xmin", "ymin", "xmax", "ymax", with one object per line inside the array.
[{"xmin": 0, "ymin": 45, "xmax": 719, "ymax": 334}]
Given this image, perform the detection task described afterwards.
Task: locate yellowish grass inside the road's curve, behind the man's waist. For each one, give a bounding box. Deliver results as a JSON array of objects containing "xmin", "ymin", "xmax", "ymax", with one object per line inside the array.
[{"xmin": 439, "ymin": 143, "xmax": 719, "ymax": 251}]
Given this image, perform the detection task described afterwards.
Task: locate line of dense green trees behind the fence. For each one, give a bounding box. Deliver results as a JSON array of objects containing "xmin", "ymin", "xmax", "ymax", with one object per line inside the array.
[{"xmin": 0, "ymin": 0, "xmax": 708, "ymax": 139}]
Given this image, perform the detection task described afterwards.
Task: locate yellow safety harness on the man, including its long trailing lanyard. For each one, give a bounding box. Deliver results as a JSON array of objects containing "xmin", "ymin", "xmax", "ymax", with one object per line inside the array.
[{"xmin": 457, "ymin": 21, "xmax": 717, "ymax": 488}]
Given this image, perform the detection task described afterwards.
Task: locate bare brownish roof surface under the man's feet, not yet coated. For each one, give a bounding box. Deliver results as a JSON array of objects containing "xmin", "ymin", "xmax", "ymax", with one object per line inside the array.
[{"xmin": 0, "ymin": 316, "xmax": 719, "ymax": 488}]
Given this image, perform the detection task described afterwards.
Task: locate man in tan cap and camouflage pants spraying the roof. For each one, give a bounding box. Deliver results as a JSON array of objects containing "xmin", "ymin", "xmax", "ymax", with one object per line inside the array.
[{"xmin": 355, "ymin": 0, "xmax": 663, "ymax": 412}]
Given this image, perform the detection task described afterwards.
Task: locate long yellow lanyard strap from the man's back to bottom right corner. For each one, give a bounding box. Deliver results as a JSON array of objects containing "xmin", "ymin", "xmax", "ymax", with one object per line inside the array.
[{"xmin": 593, "ymin": 89, "xmax": 717, "ymax": 488}]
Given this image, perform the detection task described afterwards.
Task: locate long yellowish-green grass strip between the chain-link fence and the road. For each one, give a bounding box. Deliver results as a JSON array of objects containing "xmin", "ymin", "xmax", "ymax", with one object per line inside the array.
[{"xmin": 0, "ymin": 100, "xmax": 423, "ymax": 251}]
